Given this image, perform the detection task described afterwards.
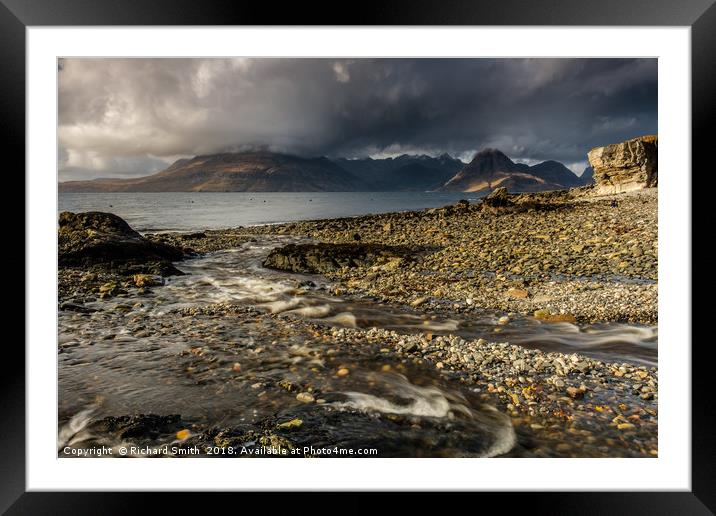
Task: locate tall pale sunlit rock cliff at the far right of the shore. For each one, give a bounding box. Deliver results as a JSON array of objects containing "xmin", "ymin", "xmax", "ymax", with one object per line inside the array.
[{"xmin": 587, "ymin": 135, "xmax": 658, "ymax": 194}]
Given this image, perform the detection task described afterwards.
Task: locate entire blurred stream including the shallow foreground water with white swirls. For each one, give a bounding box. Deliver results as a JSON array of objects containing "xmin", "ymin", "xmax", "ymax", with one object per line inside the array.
[{"xmin": 59, "ymin": 237, "xmax": 657, "ymax": 456}]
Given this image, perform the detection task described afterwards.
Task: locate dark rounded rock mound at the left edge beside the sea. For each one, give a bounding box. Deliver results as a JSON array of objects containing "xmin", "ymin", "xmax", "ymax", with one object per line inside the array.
[{"xmin": 58, "ymin": 211, "xmax": 183, "ymax": 276}]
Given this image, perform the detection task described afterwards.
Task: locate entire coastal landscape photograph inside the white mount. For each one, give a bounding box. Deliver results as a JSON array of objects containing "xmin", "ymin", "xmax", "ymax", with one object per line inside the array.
[{"xmin": 58, "ymin": 58, "xmax": 658, "ymax": 458}]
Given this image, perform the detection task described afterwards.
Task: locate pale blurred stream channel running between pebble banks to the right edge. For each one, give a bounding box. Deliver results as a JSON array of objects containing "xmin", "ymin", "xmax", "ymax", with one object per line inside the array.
[{"xmin": 131, "ymin": 237, "xmax": 657, "ymax": 365}]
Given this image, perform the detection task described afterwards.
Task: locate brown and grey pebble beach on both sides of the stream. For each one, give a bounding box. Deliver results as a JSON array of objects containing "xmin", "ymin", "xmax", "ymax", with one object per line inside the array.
[{"xmin": 59, "ymin": 189, "xmax": 658, "ymax": 457}]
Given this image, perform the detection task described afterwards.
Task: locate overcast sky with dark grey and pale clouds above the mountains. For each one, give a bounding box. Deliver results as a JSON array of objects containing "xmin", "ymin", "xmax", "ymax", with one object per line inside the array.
[{"xmin": 58, "ymin": 58, "xmax": 657, "ymax": 180}]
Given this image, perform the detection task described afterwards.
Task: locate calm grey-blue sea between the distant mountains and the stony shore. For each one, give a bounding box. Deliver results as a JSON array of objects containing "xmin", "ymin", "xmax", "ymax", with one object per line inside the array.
[{"xmin": 59, "ymin": 192, "xmax": 482, "ymax": 231}]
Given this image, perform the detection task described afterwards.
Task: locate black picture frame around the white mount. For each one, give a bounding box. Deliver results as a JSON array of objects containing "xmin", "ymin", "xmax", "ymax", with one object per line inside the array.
[{"xmin": 0, "ymin": 0, "xmax": 716, "ymax": 515}]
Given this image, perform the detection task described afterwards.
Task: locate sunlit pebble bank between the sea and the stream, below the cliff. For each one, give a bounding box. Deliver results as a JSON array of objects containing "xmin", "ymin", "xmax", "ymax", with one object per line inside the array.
[{"xmin": 245, "ymin": 189, "xmax": 658, "ymax": 323}]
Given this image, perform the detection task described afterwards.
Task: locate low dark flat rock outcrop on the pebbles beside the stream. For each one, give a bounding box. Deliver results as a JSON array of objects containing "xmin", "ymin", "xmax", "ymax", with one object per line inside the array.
[{"xmin": 263, "ymin": 243, "xmax": 414, "ymax": 274}]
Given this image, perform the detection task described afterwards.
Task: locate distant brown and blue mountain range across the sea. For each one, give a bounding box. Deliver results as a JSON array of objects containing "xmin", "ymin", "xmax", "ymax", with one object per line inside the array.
[{"xmin": 59, "ymin": 149, "xmax": 591, "ymax": 192}]
